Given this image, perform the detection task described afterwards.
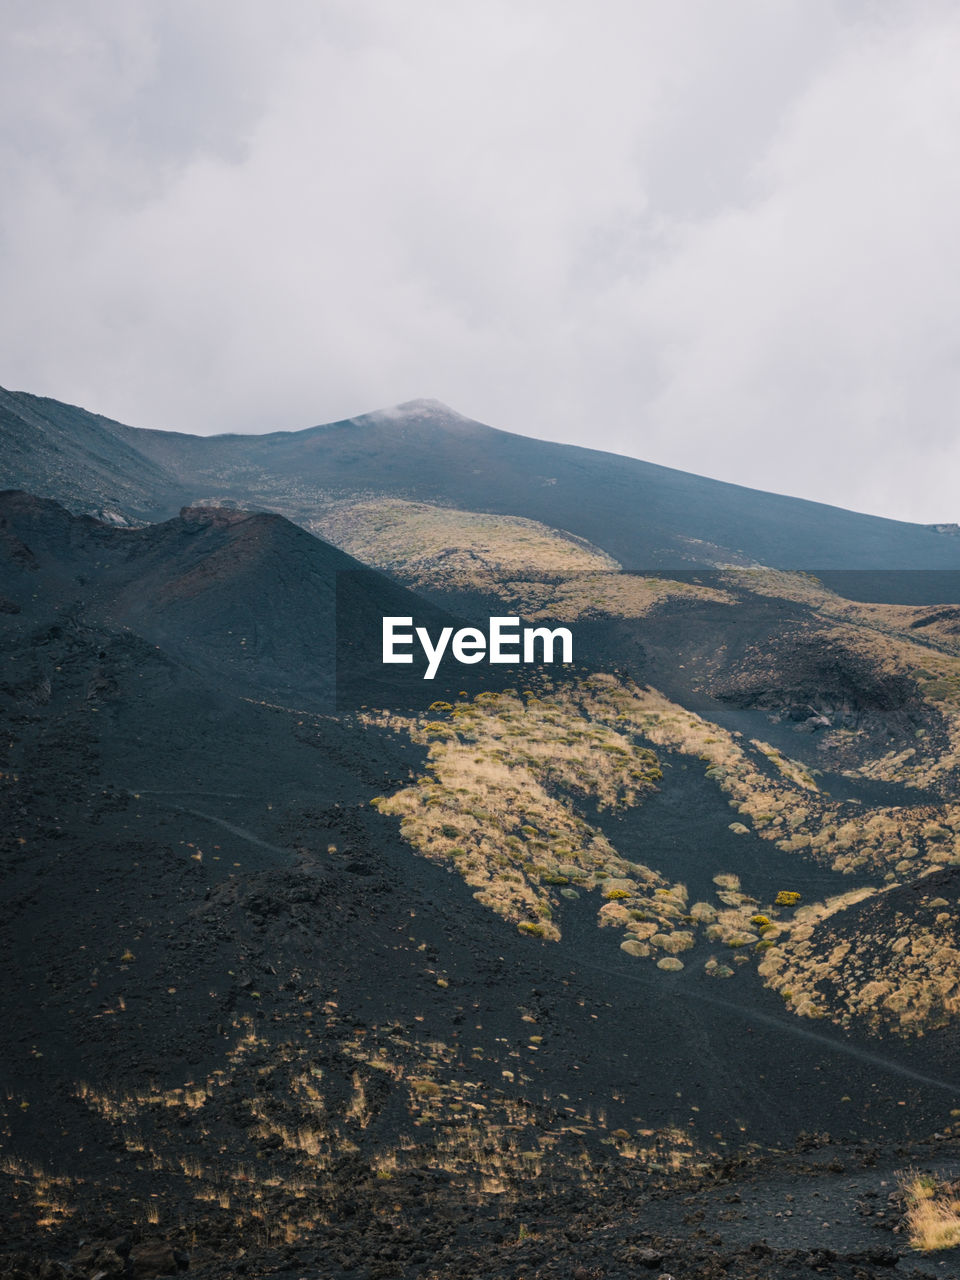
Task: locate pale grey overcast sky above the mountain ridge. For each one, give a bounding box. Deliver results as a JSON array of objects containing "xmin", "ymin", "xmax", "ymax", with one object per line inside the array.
[{"xmin": 0, "ymin": 0, "xmax": 960, "ymax": 521}]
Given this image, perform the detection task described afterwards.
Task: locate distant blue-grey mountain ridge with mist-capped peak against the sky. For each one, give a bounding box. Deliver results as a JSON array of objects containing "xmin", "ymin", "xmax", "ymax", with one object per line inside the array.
[{"xmin": 0, "ymin": 381, "xmax": 960, "ymax": 570}]
